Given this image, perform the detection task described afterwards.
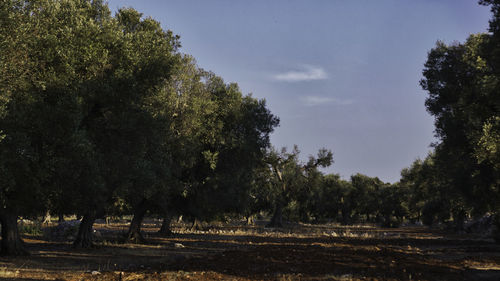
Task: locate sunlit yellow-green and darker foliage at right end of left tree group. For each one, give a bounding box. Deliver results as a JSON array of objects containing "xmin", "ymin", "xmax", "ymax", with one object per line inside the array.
[{"xmin": 160, "ymin": 56, "xmax": 279, "ymax": 220}]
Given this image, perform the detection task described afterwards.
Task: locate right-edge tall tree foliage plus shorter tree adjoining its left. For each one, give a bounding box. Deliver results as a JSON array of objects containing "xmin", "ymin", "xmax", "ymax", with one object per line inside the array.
[{"xmin": 394, "ymin": 0, "xmax": 500, "ymax": 229}]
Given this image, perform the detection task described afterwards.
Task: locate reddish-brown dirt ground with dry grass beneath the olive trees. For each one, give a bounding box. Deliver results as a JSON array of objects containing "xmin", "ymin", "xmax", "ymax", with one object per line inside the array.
[{"xmin": 0, "ymin": 220, "xmax": 500, "ymax": 281}]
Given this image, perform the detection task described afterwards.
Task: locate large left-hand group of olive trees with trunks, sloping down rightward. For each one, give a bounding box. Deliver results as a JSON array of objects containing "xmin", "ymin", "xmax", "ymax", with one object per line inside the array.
[{"xmin": 0, "ymin": 0, "xmax": 278, "ymax": 255}]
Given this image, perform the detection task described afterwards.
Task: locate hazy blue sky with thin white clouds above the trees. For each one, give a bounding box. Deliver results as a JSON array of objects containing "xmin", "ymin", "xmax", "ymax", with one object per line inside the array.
[{"xmin": 108, "ymin": 0, "xmax": 490, "ymax": 182}]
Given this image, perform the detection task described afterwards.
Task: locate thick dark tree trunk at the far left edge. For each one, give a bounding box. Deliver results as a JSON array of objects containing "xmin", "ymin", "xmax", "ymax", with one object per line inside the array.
[{"xmin": 0, "ymin": 213, "xmax": 29, "ymax": 256}]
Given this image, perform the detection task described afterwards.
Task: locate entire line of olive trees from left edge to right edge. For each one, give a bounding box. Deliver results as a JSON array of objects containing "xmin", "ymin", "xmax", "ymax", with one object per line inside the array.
[{"xmin": 0, "ymin": 0, "xmax": 500, "ymax": 255}]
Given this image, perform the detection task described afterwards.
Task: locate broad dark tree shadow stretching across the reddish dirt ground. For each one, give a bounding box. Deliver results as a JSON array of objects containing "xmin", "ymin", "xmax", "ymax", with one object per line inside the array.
[{"xmin": 0, "ymin": 226, "xmax": 500, "ymax": 280}]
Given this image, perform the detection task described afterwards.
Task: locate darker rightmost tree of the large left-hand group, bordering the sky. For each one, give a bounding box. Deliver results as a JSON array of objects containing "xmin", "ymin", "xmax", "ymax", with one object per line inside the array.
[{"xmin": 177, "ymin": 73, "xmax": 279, "ymax": 229}]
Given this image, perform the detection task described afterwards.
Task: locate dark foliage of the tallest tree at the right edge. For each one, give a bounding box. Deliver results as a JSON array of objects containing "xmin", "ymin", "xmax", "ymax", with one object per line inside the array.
[{"xmin": 421, "ymin": 1, "xmax": 500, "ymax": 217}]
